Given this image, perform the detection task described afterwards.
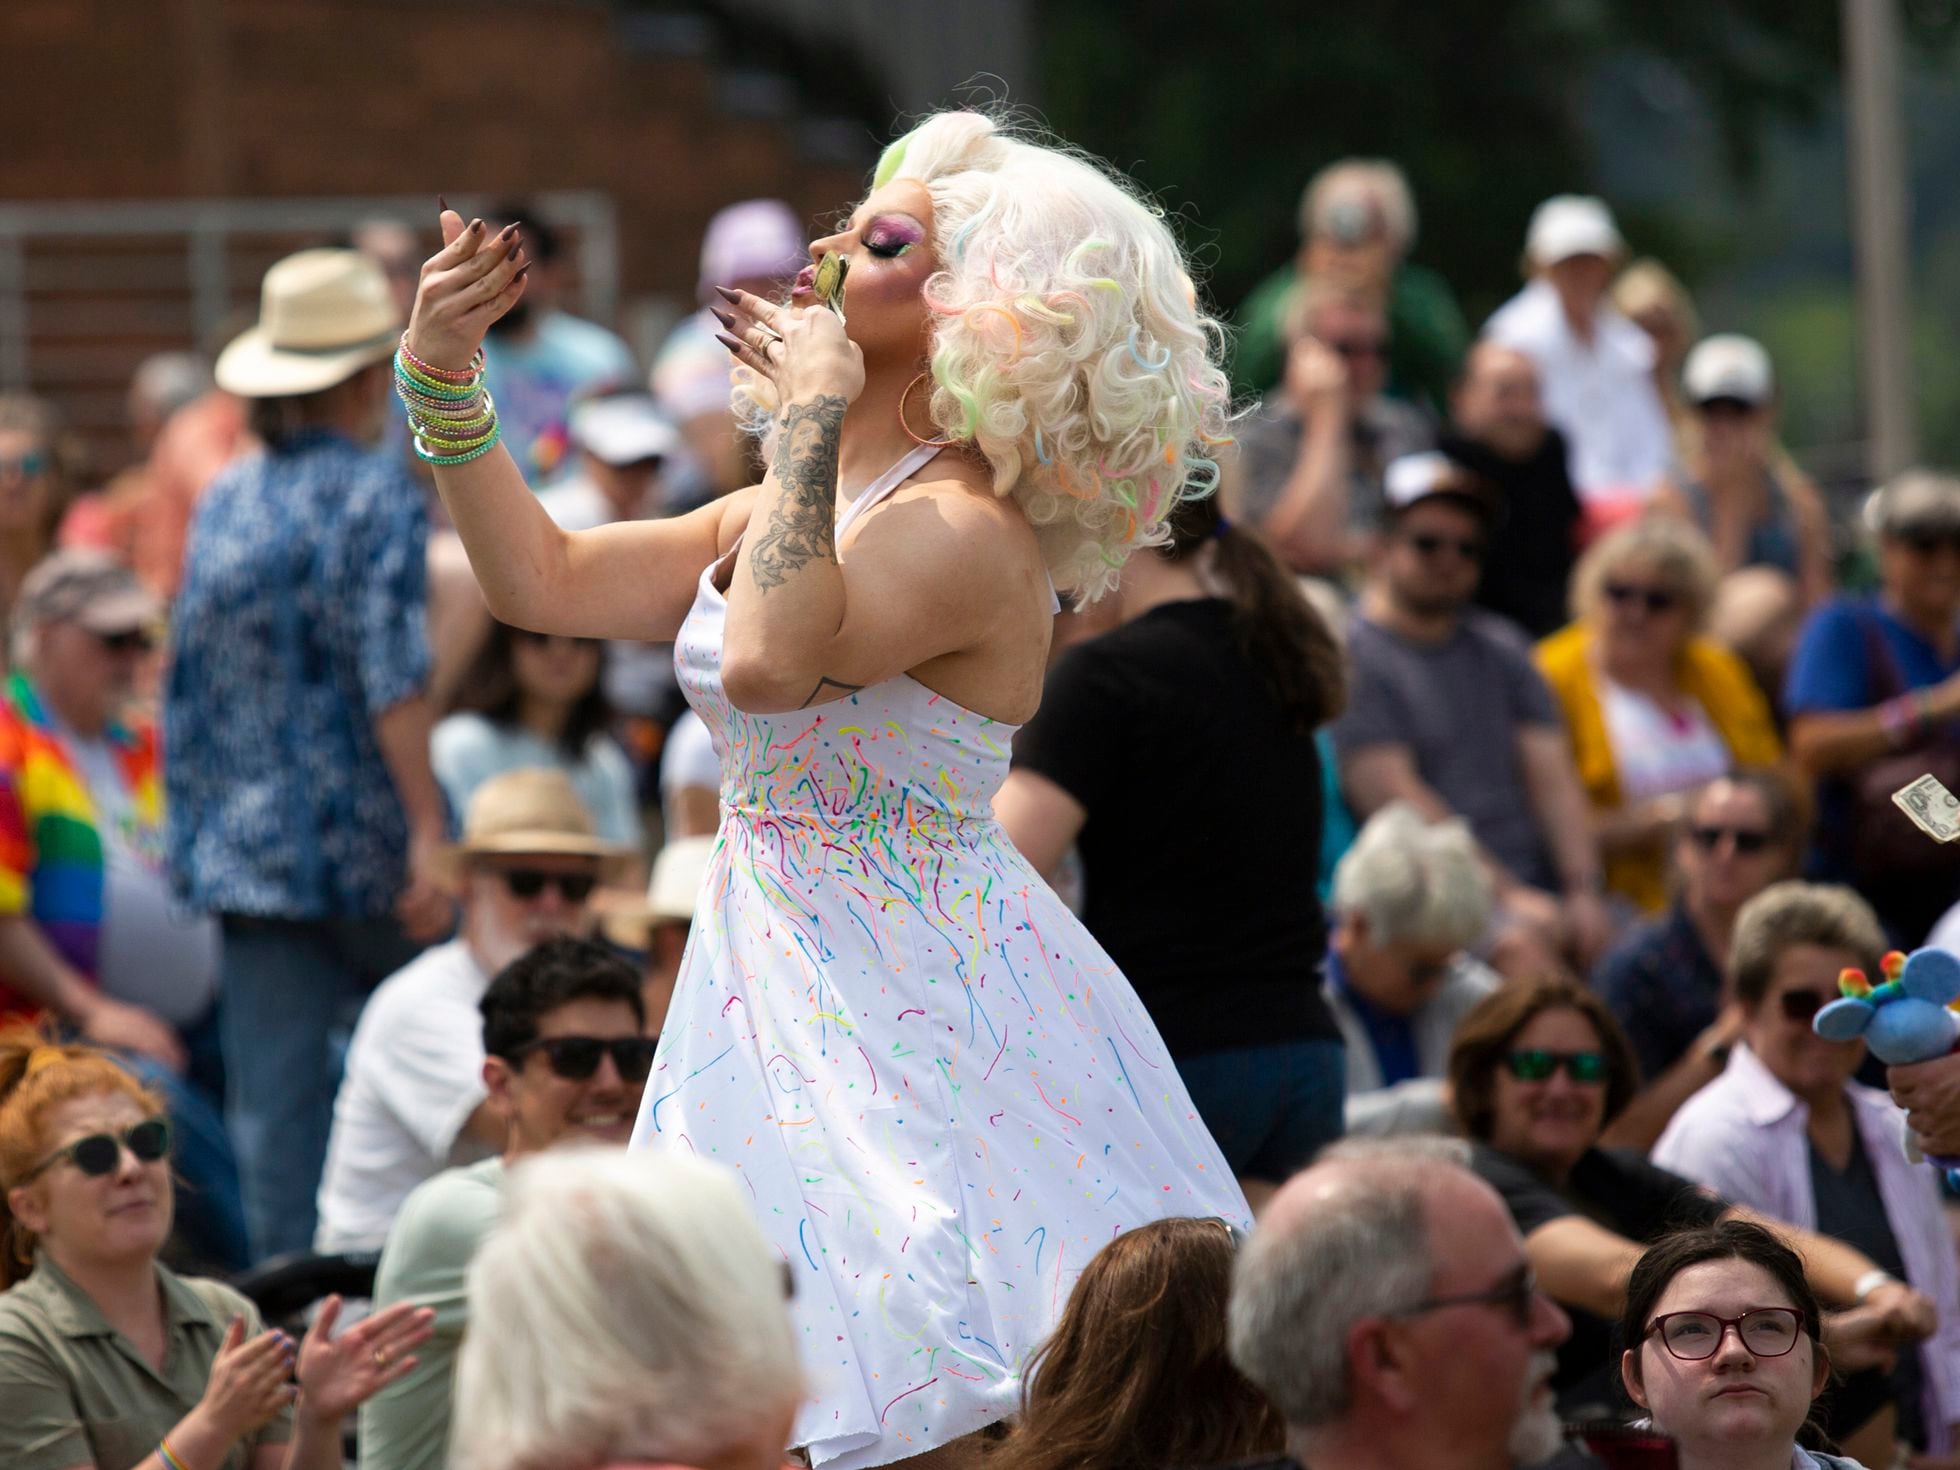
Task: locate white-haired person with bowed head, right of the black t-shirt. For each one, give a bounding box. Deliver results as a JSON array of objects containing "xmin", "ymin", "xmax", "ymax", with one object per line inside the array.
[{"xmin": 1323, "ymin": 802, "xmax": 1501, "ymax": 1133}]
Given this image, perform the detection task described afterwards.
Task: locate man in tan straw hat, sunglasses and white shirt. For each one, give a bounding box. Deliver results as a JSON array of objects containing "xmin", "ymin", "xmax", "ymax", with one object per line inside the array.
[{"xmin": 314, "ymin": 770, "xmax": 625, "ymax": 1250}]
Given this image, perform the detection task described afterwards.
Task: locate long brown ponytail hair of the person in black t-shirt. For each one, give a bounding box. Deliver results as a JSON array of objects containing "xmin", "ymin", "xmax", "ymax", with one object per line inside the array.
[{"xmin": 1160, "ymin": 496, "xmax": 1347, "ymax": 735}]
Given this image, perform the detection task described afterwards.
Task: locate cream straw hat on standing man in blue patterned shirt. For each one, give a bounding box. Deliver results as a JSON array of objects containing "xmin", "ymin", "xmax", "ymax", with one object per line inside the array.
[{"xmin": 216, "ymin": 249, "xmax": 402, "ymax": 398}]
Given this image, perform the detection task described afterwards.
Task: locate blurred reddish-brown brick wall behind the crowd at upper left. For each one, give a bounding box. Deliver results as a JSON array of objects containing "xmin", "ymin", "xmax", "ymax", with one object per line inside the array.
[{"xmin": 0, "ymin": 0, "xmax": 874, "ymax": 468}]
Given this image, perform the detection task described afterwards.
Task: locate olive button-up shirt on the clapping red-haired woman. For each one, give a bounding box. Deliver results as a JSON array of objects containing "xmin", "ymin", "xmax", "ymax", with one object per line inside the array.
[{"xmin": 0, "ymin": 1256, "xmax": 292, "ymax": 1470}]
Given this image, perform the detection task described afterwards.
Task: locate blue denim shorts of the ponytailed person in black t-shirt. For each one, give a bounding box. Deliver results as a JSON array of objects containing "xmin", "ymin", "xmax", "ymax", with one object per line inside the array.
[{"xmin": 1178, "ymin": 1041, "xmax": 1347, "ymax": 1184}]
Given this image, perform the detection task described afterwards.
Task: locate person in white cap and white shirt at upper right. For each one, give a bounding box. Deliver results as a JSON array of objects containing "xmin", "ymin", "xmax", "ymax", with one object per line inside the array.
[{"xmin": 1484, "ymin": 194, "xmax": 1674, "ymax": 519}]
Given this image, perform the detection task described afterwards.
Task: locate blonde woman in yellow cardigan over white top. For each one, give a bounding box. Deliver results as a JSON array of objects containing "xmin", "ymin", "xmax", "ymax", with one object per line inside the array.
[{"xmin": 1537, "ymin": 515, "xmax": 1784, "ymax": 913}]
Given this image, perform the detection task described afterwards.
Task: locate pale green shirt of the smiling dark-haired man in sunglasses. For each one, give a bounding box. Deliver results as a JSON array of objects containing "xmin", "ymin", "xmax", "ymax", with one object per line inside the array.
[{"xmin": 361, "ymin": 1158, "xmax": 504, "ymax": 1470}]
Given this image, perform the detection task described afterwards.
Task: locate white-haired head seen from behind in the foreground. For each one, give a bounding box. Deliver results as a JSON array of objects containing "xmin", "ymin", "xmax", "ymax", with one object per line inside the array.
[{"xmin": 449, "ymin": 1149, "xmax": 795, "ymax": 1470}]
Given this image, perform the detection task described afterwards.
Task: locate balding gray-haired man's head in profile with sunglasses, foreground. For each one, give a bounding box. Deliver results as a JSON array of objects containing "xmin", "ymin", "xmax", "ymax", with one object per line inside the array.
[{"xmin": 1229, "ymin": 1139, "xmax": 1568, "ymax": 1470}]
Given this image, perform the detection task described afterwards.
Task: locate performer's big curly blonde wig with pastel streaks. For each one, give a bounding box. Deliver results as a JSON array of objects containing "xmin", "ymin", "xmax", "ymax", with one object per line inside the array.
[{"xmin": 735, "ymin": 112, "xmax": 1231, "ymax": 602}]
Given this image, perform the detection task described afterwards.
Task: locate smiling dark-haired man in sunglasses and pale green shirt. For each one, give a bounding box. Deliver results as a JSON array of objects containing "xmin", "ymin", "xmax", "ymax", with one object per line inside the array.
[{"xmin": 361, "ymin": 939, "xmax": 655, "ymax": 1470}]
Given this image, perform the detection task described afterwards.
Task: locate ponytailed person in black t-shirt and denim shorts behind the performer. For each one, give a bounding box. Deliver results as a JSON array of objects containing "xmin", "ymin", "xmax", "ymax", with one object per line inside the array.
[{"xmin": 994, "ymin": 496, "xmax": 1347, "ymax": 1205}]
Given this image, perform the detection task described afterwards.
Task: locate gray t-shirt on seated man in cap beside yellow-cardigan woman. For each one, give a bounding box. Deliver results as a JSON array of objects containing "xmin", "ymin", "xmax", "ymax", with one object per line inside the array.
[{"xmin": 1333, "ymin": 610, "xmax": 1558, "ymax": 888}]
